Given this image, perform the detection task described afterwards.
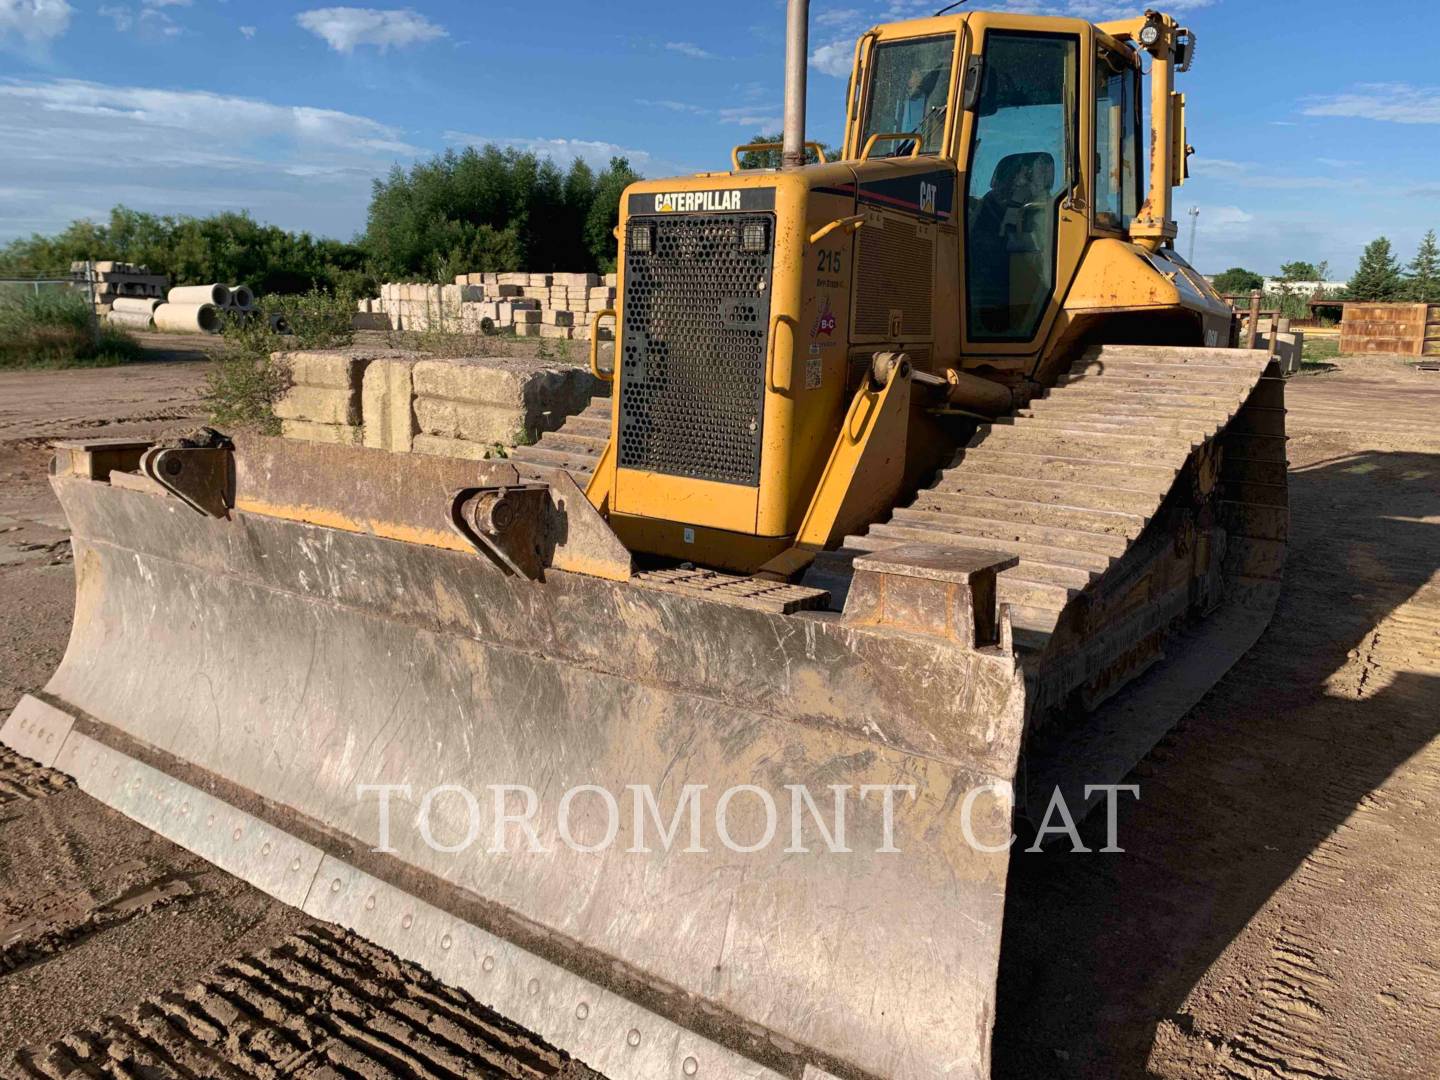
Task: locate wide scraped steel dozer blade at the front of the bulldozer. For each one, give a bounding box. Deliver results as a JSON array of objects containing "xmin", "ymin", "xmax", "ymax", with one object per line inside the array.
[{"xmin": 0, "ymin": 439, "xmax": 1027, "ymax": 1080}]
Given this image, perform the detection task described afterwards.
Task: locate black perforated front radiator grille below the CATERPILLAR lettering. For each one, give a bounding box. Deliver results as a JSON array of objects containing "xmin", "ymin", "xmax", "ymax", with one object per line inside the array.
[{"xmin": 618, "ymin": 213, "xmax": 775, "ymax": 487}]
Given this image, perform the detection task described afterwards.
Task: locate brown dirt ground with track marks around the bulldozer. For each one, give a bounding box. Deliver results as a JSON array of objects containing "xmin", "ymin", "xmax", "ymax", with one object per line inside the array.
[{"xmin": 0, "ymin": 359, "xmax": 1440, "ymax": 1080}]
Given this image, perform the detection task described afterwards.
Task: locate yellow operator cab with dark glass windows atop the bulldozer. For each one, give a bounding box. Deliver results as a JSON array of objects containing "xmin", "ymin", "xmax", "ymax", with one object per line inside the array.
[{"xmin": 847, "ymin": 13, "xmax": 1142, "ymax": 354}]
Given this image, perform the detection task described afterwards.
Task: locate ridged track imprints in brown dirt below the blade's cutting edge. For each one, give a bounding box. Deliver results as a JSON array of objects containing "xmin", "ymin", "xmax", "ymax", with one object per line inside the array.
[{"xmin": 4, "ymin": 924, "xmax": 596, "ymax": 1080}]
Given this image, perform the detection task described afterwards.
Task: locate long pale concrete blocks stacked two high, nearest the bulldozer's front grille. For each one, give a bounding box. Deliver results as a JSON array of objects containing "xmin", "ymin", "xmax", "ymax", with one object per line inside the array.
[{"xmin": 412, "ymin": 357, "xmax": 600, "ymax": 459}]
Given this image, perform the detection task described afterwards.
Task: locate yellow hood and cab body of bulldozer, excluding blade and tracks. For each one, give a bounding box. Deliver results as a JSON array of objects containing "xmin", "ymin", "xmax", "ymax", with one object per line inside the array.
[{"xmin": 589, "ymin": 13, "xmax": 1230, "ymax": 572}]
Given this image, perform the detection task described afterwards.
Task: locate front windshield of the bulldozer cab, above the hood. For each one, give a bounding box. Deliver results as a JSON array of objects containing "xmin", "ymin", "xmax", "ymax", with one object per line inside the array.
[{"xmin": 860, "ymin": 35, "xmax": 955, "ymax": 157}]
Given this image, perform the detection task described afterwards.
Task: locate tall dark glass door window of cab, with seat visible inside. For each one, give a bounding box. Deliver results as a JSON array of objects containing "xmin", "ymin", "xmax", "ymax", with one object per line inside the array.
[{"xmin": 965, "ymin": 30, "xmax": 1080, "ymax": 341}]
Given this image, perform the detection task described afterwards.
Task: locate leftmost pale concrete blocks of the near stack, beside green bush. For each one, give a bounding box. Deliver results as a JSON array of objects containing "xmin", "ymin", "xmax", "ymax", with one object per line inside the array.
[{"xmin": 275, "ymin": 348, "xmax": 413, "ymax": 446}]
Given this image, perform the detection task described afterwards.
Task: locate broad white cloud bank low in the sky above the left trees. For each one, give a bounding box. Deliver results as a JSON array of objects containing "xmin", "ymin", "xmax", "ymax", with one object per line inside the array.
[{"xmin": 0, "ymin": 78, "xmax": 420, "ymax": 236}]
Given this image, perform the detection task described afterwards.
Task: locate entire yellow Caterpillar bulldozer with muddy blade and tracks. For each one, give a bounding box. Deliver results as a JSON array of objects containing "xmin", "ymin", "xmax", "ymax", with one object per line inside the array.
[{"xmin": 3, "ymin": 0, "xmax": 1287, "ymax": 1080}]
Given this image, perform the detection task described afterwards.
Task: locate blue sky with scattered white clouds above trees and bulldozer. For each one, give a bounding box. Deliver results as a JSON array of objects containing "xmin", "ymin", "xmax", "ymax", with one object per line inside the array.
[{"xmin": 0, "ymin": 0, "xmax": 1440, "ymax": 276}]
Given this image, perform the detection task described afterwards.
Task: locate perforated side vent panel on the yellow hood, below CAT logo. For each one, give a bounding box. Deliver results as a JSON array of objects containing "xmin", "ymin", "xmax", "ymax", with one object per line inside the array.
[{"xmin": 855, "ymin": 217, "xmax": 935, "ymax": 341}]
